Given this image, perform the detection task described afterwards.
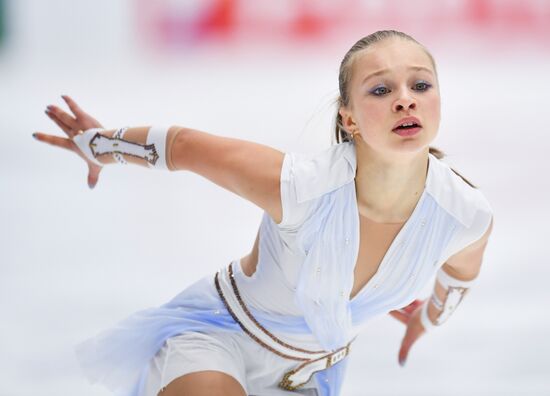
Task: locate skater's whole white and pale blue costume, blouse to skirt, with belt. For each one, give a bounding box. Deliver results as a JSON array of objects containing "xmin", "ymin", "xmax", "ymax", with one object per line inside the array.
[{"xmin": 75, "ymin": 142, "xmax": 492, "ymax": 396}]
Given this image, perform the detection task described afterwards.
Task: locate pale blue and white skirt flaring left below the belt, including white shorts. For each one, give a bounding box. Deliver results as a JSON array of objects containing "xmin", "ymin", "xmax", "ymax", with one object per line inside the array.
[{"xmin": 77, "ymin": 268, "xmax": 347, "ymax": 396}]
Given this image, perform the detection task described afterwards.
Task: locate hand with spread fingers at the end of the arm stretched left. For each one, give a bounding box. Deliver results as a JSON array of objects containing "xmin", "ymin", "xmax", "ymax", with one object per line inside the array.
[{"xmin": 33, "ymin": 95, "xmax": 103, "ymax": 188}]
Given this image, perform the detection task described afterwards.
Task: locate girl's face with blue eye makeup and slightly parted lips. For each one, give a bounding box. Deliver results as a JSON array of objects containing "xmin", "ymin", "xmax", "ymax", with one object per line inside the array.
[{"xmin": 340, "ymin": 38, "xmax": 440, "ymax": 159}]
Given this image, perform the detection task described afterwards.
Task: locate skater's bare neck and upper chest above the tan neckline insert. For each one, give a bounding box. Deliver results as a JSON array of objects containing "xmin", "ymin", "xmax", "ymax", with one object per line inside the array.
[{"xmin": 355, "ymin": 139, "xmax": 428, "ymax": 223}]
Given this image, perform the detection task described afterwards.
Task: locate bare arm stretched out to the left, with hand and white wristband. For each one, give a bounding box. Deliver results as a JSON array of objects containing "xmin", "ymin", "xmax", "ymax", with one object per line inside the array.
[{"xmin": 33, "ymin": 97, "xmax": 284, "ymax": 223}]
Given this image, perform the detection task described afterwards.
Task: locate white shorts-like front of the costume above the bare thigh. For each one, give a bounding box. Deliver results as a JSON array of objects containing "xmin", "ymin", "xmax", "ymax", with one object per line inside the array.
[{"xmin": 145, "ymin": 330, "xmax": 318, "ymax": 396}]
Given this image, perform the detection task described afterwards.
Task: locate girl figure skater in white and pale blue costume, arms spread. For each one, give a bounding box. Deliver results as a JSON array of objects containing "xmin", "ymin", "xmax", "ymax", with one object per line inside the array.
[{"xmin": 34, "ymin": 31, "xmax": 492, "ymax": 396}]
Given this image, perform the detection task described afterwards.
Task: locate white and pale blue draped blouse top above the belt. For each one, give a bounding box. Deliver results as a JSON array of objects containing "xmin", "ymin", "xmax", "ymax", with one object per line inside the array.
[{"xmin": 236, "ymin": 142, "xmax": 492, "ymax": 349}]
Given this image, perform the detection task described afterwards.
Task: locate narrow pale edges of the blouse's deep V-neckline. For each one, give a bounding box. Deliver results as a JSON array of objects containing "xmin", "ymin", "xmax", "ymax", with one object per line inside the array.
[{"xmin": 348, "ymin": 154, "xmax": 433, "ymax": 303}]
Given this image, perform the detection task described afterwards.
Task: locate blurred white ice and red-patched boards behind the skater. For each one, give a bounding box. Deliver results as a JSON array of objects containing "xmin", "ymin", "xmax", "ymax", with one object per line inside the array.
[{"xmin": 0, "ymin": 0, "xmax": 550, "ymax": 396}]
